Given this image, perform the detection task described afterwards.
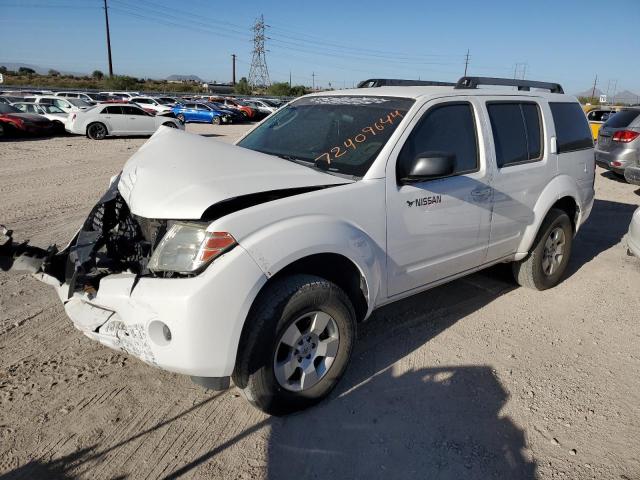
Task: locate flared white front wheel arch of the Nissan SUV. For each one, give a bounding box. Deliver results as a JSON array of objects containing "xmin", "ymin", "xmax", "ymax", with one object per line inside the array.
[{"xmin": 241, "ymin": 215, "xmax": 384, "ymax": 315}]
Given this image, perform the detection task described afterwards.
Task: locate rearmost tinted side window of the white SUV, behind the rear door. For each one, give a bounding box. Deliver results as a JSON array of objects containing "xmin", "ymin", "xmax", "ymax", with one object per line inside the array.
[{"xmin": 549, "ymin": 102, "xmax": 593, "ymax": 153}]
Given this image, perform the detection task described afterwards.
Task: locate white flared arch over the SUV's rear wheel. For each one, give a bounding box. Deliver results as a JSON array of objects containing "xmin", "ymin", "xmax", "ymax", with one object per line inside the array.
[{"xmin": 516, "ymin": 175, "xmax": 583, "ymax": 255}]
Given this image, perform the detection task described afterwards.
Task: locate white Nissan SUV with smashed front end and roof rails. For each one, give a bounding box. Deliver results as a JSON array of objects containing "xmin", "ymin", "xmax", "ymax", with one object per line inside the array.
[{"xmin": 0, "ymin": 77, "xmax": 595, "ymax": 414}]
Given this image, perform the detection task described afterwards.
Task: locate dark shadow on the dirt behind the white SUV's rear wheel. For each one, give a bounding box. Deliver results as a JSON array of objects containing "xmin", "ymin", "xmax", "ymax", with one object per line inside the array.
[{"xmin": 565, "ymin": 199, "xmax": 638, "ymax": 281}]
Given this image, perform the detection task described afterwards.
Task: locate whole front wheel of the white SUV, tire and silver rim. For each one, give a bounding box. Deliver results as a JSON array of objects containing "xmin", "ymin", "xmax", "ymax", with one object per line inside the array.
[{"xmin": 232, "ymin": 275, "xmax": 356, "ymax": 415}]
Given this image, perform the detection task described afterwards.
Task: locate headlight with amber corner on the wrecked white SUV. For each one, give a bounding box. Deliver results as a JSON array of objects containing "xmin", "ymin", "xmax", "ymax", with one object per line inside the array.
[{"xmin": 148, "ymin": 223, "xmax": 236, "ymax": 273}]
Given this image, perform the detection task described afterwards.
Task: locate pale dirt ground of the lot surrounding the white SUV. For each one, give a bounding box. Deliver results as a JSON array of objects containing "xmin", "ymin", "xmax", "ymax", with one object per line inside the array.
[{"xmin": 0, "ymin": 126, "xmax": 640, "ymax": 480}]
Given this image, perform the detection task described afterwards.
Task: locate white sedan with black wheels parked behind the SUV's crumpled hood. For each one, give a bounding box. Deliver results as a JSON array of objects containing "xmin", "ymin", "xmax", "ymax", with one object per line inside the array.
[{"xmin": 67, "ymin": 103, "xmax": 184, "ymax": 140}]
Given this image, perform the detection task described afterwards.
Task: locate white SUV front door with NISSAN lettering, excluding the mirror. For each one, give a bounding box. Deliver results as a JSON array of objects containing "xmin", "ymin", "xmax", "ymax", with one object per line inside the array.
[{"xmin": 387, "ymin": 100, "xmax": 493, "ymax": 296}]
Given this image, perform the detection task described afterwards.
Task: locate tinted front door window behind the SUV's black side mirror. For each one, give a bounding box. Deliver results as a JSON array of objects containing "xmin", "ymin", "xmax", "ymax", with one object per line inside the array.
[{"xmin": 398, "ymin": 103, "xmax": 478, "ymax": 174}]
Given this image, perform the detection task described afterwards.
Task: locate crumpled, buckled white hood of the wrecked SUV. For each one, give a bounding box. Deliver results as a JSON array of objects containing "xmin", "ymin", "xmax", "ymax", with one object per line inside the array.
[{"xmin": 118, "ymin": 127, "xmax": 351, "ymax": 220}]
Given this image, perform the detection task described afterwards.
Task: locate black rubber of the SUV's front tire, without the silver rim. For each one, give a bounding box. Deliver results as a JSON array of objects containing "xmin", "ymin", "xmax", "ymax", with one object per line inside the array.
[{"xmin": 232, "ymin": 275, "xmax": 356, "ymax": 415}]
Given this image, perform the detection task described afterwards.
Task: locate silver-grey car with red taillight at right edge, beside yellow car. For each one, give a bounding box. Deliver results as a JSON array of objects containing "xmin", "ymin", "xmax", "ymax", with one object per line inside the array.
[{"xmin": 596, "ymin": 108, "xmax": 640, "ymax": 176}]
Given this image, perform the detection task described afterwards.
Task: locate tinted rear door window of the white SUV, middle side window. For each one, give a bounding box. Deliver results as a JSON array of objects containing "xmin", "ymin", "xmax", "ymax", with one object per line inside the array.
[{"xmin": 487, "ymin": 102, "xmax": 542, "ymax": 168}]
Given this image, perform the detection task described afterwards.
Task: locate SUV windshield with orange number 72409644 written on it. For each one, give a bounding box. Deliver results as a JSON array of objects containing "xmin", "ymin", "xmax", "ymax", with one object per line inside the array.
[{"xmin": 238, "ymin": 96, "xmax": 414, "ymax": 177}]
